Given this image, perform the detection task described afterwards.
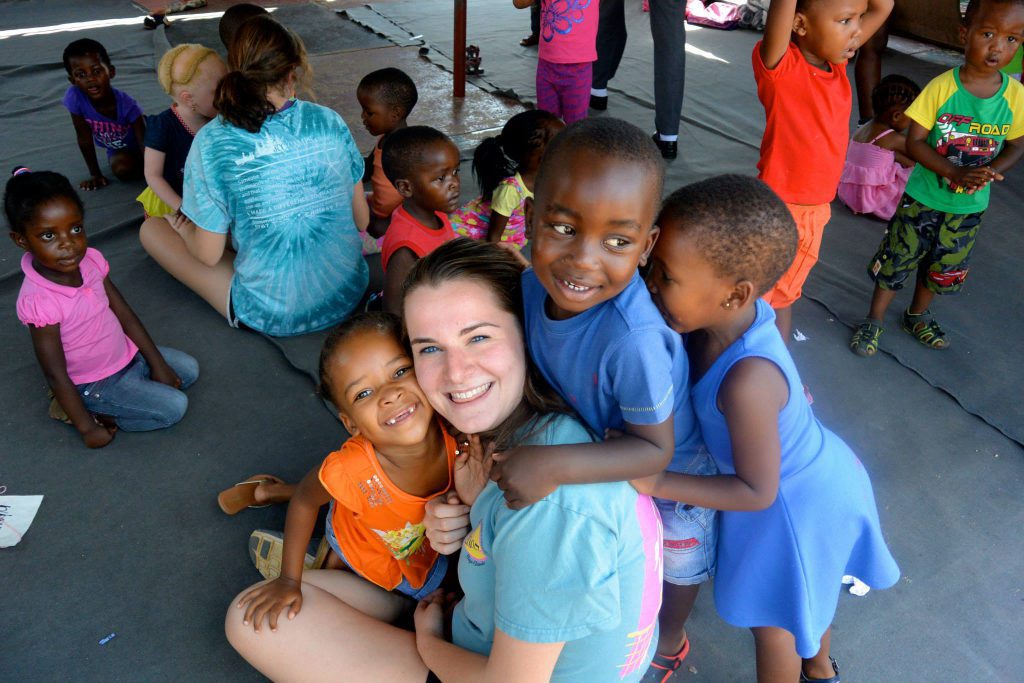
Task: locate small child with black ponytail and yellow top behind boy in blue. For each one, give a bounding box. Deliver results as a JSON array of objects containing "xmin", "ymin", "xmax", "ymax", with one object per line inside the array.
[{"xmin": 452, "ymin": 110, "xmax": 565, "ymax": 249}]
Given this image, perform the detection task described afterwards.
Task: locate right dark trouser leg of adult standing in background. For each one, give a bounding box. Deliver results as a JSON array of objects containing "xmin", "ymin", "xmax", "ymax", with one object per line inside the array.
[{"xmin": 651, "ymin": 0, "xmax": 686, "ymax": 141}]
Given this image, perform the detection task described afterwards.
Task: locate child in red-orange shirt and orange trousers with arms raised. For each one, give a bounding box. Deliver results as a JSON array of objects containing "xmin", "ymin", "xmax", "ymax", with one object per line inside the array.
[{"xmin": 753, "ymin": 0, "xmax": 893, "ymax": 342}]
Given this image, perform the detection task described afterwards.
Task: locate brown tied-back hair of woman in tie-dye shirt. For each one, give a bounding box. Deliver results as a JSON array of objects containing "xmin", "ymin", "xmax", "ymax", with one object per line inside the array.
[{"xmin": 213, "ymin": 14, "xmax": 312, "ymax": 133}]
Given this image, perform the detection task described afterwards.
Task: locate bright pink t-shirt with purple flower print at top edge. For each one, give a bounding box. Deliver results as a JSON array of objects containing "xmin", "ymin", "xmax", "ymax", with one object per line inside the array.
[{"xmin": 538, "ymin": 0, "xmax": 598, "ymax": 65}]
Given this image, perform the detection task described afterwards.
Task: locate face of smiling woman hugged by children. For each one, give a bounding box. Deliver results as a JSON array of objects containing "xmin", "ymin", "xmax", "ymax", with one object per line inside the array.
[{"xmin": 404, "ymin": 280, "xmax": 526, "ymax": 434}]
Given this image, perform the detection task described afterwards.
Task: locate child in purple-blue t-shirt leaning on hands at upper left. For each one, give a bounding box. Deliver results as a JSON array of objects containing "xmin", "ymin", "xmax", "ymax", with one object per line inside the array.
[{"xmin": 63, "ymin": 38, "xmax": 145, "ymax": 189}]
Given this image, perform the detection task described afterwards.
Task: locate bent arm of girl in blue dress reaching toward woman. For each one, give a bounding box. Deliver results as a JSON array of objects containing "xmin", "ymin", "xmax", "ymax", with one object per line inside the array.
[{"xmin": 634, "ymin": 357, "xmax": 790, "ymax": 511}]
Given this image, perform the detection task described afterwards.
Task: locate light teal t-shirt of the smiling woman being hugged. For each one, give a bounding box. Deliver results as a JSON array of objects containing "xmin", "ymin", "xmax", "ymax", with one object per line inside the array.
[{"xmin": 452, "ymin": 416, "xmax": 662, "ymax": 682}]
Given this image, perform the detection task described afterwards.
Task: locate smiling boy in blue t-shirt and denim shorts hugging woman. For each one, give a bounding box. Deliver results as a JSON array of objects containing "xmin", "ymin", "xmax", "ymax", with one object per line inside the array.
[{"xmin": 493, "ymin": 118, "xmax": 717, "ymax": 680}]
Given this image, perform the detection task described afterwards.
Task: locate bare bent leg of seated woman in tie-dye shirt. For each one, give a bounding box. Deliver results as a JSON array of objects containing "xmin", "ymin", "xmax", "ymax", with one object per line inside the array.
[{"xmin": 138, "ymin": 216, "xmax": 234, "ymax": 318}]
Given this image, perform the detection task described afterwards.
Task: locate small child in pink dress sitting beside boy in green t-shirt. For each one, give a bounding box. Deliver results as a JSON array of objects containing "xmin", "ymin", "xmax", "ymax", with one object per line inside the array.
[{"xmin": 839, "ymin": 74, "xmax": 921, "ymax": 220}]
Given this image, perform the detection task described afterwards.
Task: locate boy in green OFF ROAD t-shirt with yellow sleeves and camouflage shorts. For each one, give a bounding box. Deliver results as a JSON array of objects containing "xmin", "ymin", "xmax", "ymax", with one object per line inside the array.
[{"xmin": 850, "ymin": 0, "xmax": 1024, "ymax": 356}]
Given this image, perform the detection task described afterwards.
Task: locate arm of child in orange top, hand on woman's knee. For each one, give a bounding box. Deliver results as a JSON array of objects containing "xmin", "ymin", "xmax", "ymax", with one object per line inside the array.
[{"xmin": 238, "ymin": 466, "xmax": 331, "ymax": 633}]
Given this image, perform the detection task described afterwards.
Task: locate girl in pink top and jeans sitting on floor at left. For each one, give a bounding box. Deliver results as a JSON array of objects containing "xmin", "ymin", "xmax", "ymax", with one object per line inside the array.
[{"xmin": 3, "ymin": 167, "xmax": 199, "ymax": 449}]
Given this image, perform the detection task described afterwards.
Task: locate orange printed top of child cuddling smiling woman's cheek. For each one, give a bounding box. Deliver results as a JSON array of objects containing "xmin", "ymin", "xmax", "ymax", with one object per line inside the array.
[{"xmin": 319, "ymin": 426, "xmax": 456, "ymax": 590}]
